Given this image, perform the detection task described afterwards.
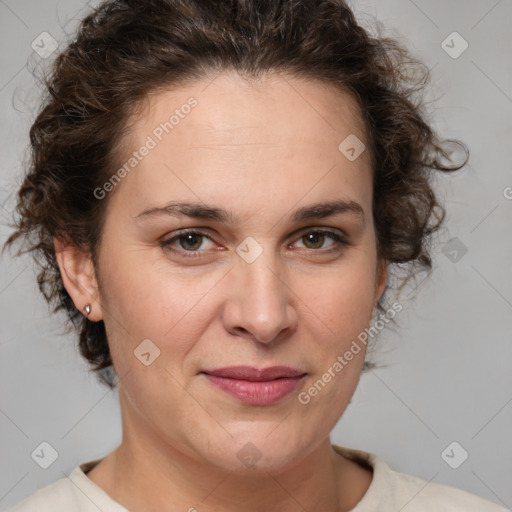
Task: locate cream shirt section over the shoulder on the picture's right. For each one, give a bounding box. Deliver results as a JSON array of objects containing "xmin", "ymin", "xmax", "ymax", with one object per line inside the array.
[{"xmin": 333, "ymin": 445, "xmax": 509, "ymax": 512}]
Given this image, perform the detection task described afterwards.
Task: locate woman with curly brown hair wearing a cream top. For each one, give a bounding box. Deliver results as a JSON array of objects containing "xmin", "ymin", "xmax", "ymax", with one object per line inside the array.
[{"xmin": 3, "ymin": 0, "xmax": 504, "ymax": 512}]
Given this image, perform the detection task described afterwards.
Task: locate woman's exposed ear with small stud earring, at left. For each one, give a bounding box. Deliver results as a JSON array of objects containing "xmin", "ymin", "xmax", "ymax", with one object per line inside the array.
[{"xmin": 53, "ymin": 238, "xmax": 103, "ymax": 322}]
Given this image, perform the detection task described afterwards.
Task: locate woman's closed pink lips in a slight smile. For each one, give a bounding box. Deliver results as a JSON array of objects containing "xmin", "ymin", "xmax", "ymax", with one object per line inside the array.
[{"xmin": 202, "ymin": 366, "xmax": 305, "ymax": 405}]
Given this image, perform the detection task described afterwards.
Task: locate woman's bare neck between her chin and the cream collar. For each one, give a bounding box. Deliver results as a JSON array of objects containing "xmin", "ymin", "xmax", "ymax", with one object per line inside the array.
[{"xmin": 87, "ymin": 392, "xmax": 372, "ymax": 512}]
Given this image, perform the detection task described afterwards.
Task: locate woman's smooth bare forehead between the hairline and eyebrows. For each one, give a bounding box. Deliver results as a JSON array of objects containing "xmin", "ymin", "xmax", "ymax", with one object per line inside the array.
[{"xmin": 108, "ymin": 72, "xmax": 370, "ymax": 213}]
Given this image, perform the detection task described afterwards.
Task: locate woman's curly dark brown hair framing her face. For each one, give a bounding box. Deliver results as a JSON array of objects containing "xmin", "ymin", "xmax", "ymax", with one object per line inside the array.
[{"xmin": 3, "ymin": 0, "xmax": 467, "ymax": 388}]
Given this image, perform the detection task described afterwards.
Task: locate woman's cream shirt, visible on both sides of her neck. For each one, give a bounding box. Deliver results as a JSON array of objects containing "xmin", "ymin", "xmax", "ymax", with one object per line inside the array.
[{"xmin": 8, "ymin": 445, "xmax": 508, "ymax": 512}]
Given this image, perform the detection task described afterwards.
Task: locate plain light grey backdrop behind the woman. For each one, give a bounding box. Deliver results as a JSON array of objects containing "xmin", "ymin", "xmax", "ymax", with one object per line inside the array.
[{"xmin": 0, "ymin": 0, "xmax": 512, "ymax": 510}]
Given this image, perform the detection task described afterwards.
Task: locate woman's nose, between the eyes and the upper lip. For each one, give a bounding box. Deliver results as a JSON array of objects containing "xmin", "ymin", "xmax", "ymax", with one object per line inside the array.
[{"xmin": 223, "ymin": 251, "xmax": 297, "ymax": 343}]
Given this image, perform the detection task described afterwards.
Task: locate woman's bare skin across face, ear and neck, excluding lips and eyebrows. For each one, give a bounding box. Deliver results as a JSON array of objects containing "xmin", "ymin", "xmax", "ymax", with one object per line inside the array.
[{"xmin": 55, "ymin": 72, "xmax": 387, "ymax": 512}]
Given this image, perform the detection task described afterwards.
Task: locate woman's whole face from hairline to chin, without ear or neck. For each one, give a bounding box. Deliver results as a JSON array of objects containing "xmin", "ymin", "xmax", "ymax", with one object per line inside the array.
[{"xmin": 94, "ymin": 73, "xmax": 385, "ymax": 472}]
